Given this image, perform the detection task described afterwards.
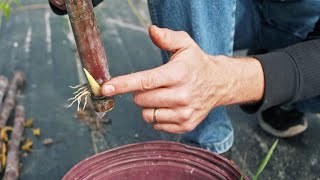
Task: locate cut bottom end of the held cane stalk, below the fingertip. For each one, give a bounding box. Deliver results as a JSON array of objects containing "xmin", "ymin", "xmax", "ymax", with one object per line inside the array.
[{"xmin": 91, "ymin": 95, "xmax": 115, "ymax": 112}]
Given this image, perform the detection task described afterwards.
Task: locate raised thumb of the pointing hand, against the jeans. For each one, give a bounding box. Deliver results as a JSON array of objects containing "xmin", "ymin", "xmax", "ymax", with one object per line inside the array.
[{"xmin": 149, "ymin": 25, "xmax": 195, "ymax": 52}]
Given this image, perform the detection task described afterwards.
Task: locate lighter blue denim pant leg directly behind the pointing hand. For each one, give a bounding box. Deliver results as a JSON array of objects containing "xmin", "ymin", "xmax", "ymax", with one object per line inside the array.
[{"xmin": 148, "ymin": 0, "xmax": 236, "ymax": 153}]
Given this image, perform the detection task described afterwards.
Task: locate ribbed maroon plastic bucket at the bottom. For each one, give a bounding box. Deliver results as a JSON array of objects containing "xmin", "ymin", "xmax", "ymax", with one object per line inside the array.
[{"xmin": 63, "ymin": 141, "xmax": 248, "ymax": 180}]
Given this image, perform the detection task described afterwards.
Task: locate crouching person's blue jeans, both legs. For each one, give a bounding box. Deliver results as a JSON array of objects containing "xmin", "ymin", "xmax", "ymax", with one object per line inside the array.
[{"xmin": 148, "ymin": 0, "xmax": 320, "ymax": 153}]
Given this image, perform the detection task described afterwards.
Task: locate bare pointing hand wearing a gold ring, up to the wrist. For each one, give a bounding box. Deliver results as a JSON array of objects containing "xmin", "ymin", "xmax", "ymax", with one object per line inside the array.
[{"xmin": 102, "ymin": 26, "xmax": 259, "ymax": 134}]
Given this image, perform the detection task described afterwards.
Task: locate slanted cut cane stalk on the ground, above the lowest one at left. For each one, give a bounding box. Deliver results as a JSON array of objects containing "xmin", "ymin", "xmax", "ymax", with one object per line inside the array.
[{"xmin": 0, "ymin": 71, "xmax": 24, "ymax": 128}]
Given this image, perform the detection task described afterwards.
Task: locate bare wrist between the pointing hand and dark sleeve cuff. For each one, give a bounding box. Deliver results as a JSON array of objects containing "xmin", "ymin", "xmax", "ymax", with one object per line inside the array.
[{"xmin": 213, "ymin": 56, "xmax": 265, "ymax": 105}]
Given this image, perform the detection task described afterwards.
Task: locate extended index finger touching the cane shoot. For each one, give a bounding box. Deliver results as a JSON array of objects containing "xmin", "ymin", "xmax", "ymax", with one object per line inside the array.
[{"xmin": 102, "ymin": 64, "xmax": 182, "ymax": 96}]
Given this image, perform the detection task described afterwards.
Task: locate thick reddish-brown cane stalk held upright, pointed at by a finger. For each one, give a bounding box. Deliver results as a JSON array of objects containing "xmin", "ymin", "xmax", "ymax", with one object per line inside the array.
[{"xmin": 65, "ymin": 0, "xmax": 114, "ymax": 112}]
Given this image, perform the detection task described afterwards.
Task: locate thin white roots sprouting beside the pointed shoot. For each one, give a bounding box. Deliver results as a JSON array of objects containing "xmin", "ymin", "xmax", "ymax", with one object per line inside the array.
[{"xmin": 68, "ymin": 84, "xmax": 91, "ymax": 111}]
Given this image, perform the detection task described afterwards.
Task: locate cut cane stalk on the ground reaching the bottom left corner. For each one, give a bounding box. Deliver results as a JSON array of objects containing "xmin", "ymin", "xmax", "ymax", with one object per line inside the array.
[{"xmin": 3, "ymin": 105, "xmax": 25, "ymax": 180}]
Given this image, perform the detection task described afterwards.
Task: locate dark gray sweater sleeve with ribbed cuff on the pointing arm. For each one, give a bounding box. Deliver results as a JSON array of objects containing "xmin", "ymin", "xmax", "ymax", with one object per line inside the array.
[{"xmin": 241, "ymin": 18, "xmax": 320, "ymax": 113}]
